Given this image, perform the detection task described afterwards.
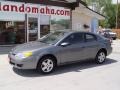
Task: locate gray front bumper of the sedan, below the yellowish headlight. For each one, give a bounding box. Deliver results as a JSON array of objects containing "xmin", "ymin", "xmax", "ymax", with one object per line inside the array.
[{"xmin": 8, "ymin": 54, "xmax": 38, "ymax": 69}]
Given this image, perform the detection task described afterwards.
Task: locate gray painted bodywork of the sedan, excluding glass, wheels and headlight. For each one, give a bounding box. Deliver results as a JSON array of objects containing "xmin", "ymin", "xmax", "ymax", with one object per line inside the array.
[{"xmin": 9, "ymin": 31, "xmax": 112, "ymax": 69}]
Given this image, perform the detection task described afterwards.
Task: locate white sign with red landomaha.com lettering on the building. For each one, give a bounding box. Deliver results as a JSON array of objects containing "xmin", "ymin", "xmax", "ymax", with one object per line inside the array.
[{"xmin": 0, "ymin": 1, "xmax": 70, "ymax": 16}]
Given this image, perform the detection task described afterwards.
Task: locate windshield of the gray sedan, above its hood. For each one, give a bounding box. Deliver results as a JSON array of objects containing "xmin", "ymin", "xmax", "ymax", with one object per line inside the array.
[{"xmin": 39, "ymin": 31, "xmax": 66, "ymax": 44}]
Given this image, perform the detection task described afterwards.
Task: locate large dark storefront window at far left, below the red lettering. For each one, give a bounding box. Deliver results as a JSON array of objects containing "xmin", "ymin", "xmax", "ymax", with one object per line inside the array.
[{"xmin": 0, "ymin": 21, "xmax": 25, "ymax": 45}]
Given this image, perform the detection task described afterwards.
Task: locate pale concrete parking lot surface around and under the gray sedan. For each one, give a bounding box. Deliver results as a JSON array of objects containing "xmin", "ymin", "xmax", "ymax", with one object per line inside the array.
[{"xmin": 0, "ymin": 40, "xmax": 120, "ymax": 90}]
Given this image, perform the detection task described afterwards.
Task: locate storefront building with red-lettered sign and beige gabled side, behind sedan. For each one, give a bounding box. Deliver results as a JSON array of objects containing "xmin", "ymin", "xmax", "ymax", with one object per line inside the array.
[{"xmin": 0, "ymin": 0, "xmax": 104, "ymax": 45}]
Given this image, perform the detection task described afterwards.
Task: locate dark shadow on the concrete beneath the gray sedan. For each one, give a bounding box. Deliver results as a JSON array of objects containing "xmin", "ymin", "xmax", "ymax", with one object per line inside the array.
[{"xmin": 13, "ymin": 58, "xmax": 117, "ymax": 77}]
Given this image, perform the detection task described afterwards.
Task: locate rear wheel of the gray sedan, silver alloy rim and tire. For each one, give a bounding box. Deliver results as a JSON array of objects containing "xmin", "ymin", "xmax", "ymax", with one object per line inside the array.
[{"xmin": 95, "ymin": 51, "xmax": 106, "ymax": 64}]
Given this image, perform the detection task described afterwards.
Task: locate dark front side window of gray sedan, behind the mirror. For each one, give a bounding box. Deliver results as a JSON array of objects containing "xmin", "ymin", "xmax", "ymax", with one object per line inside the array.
[{"xmin": 63, "ymin": 33, "xmax": 84, "ymax": 44}]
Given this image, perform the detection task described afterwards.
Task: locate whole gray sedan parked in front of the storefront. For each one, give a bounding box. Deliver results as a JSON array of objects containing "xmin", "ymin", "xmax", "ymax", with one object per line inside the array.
[{"xmin": 8, "ymin": 31, "xmax": 112, "ymax": 74}]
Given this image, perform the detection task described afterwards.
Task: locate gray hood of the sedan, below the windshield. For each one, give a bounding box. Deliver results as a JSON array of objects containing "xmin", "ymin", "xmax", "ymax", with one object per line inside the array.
[{"xmin": 12, "ymin": 41, "xmax": 50, "ymax": 53}]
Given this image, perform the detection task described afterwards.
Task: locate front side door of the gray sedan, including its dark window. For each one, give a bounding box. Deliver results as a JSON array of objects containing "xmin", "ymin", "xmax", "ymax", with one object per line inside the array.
[{"xmin": 59, "ymin": 33, "xmax": 85, "ymax": 63}]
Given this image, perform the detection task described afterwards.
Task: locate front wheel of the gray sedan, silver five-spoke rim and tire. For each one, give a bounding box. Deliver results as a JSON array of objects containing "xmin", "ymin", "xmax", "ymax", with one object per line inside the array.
[{"xmin": 36, "ymin": 56, "xmax": 56, "ymax": 74}]
